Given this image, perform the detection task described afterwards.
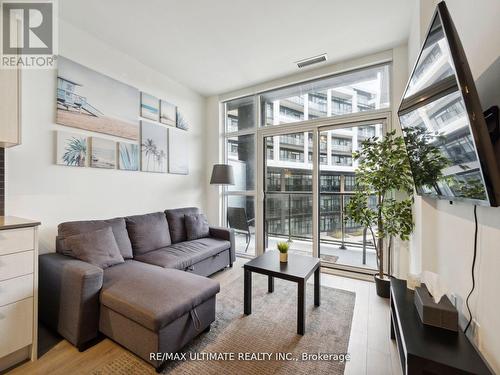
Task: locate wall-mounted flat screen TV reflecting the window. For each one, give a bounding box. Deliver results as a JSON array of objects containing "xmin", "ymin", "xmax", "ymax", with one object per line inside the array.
[{"xmin": 398, "ymin": 2, "xmax": 500, "ymax": 206}]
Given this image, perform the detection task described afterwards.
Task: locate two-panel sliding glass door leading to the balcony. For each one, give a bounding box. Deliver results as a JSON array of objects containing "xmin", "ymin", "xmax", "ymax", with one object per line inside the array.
[{"xmin": 259, "ymin": 118, "xmax": 387, "ymax": 272}]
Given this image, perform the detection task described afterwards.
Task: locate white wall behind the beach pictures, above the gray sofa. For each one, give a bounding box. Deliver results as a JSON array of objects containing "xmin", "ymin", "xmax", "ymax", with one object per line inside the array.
[{"xmin": 6, "ymin": 21, "xmax": 206, "ymax": 252}]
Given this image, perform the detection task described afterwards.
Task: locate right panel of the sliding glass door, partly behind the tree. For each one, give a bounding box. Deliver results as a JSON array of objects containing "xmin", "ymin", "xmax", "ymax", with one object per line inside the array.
[{"xmin": 318, "ymin": 122, "xmax": 383, "ymax": 269}]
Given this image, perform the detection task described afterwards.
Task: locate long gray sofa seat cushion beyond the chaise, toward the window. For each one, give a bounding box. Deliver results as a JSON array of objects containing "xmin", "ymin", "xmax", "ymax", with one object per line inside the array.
[{"xmin": 135, "ymin": 237, "xmax": 231, "ymax": 270}]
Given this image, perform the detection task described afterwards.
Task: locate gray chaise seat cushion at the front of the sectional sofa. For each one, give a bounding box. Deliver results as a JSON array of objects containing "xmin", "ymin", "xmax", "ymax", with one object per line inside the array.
[{"xmin": 100, "ymin": 260, "xmax": 220, "ymax": 332}]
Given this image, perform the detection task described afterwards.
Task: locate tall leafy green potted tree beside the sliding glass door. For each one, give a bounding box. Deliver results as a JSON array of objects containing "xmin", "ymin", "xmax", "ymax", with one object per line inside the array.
[{"xmin": 345, "ymin": 131, "xmax": 413, "ymax": 298}]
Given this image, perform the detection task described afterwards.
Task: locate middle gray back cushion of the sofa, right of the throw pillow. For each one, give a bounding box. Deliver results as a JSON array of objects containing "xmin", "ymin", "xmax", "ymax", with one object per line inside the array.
[{"xmin": 125, "ymin": 212, "xmax": 172, "ymax": 256}]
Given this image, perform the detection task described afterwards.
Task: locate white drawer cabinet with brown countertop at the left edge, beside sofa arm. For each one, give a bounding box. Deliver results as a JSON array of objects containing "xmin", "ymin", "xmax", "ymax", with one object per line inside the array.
[{"xmin": 0, "ymin": 216, "xmax": 40, "ymax": 373}]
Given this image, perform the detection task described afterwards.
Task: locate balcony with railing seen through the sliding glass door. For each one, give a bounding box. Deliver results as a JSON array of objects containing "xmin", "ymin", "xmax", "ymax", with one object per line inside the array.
[{"xmin": 254, "ymin": 192, "xmax": 377, "ymax": 269}]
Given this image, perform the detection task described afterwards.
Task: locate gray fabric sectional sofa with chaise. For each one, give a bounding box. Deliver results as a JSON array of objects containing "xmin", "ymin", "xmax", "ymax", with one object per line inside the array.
[{"xmin": 39, "ymin": 207, "xmax": 235, "ymax": 370}]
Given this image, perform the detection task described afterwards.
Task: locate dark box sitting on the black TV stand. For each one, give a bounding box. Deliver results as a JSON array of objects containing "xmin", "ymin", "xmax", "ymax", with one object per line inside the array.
[{"xmin": 414, "ymin": 284, "xmax": 458, "ymax": 332}]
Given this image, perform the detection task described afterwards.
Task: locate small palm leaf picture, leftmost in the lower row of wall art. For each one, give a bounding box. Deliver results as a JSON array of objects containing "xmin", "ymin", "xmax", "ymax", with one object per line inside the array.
[{"xmin": 57, "ymin": 131, "xmax": 88, "ymax": 167}]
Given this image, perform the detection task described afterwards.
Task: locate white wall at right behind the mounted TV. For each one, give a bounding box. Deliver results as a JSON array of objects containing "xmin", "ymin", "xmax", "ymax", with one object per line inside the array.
[{"xmin": 408, "ymin": 0, "xmax": 500, "ymax": 372}]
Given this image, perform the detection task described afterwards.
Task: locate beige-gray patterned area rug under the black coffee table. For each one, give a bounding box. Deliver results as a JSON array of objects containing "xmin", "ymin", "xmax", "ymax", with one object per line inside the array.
[{"xmin": 94, "ymin": 274, "xmax": 355, "ymax": 375}]
